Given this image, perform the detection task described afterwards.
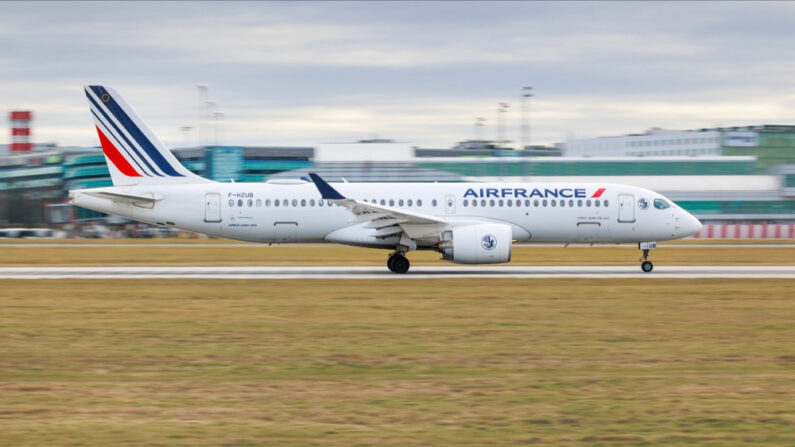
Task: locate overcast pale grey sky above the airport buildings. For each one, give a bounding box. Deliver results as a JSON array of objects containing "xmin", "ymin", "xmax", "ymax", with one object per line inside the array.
[{"xmin": 0, "ymin": 1, "xmax": 795, "ymax": 148}]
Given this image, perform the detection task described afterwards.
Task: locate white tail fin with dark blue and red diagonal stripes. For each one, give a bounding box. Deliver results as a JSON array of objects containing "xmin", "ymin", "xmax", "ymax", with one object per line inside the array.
[{"xmin": 84, "ymin": 85, "xmax": 210, "ymax": 186}]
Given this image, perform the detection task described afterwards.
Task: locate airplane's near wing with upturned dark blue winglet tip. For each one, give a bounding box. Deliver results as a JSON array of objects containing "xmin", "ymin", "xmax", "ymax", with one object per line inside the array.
[{"xmin": 309, "ymin": 173, "xmax": 448, "ymax": 242}]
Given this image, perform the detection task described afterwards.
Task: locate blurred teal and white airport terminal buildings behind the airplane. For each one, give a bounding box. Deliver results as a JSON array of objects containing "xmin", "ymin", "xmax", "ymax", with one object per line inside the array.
[{"xmin": 0, "ymin": 117, "xmax": 795, "ymax": 240}]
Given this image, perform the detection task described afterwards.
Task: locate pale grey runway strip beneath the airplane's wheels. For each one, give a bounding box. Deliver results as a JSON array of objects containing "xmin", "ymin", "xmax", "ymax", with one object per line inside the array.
[{"xmin": 0, "ymin": 265, "xmax": 795, "ymax": 280}]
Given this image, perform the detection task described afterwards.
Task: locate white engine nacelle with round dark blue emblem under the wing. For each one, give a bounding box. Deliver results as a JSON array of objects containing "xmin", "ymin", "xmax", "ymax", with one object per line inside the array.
[{"xmin": 439, "ymin": 223, "xmax": 513, "ymax": 264}]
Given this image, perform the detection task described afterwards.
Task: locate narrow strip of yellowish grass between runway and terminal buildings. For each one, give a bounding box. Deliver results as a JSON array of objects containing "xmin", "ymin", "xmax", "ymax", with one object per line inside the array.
[{"xmin": 0, "ymin": 240, "xmax": 795, "ymax": 267}]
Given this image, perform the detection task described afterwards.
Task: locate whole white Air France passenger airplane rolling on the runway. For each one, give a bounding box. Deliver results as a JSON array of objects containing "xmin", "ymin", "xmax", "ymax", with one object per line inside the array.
[{"xmin": 69, "ymin": 85, "xmax": 702, "ymax": 273}]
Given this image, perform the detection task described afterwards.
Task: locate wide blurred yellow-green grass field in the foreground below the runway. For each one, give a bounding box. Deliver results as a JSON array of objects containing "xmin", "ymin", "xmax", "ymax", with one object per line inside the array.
[{"xmin": 0, "ymin": 278, "xmax": 795, "ymax": 446}]
